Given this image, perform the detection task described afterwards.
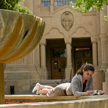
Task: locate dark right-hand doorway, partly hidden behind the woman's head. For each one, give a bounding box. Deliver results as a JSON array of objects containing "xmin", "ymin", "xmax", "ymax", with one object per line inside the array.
[{"xmin": 72, "ymin": 38, "xmax": 92, "ymax": 74}]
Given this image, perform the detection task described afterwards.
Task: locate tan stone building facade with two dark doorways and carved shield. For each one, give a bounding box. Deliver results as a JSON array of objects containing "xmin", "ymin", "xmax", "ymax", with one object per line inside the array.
[{"xmin": 5, "ymin": 0, "xmax": 108, "ymax": 94}]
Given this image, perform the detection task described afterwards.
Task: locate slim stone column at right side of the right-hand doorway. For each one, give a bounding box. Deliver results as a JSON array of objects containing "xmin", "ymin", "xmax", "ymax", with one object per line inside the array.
[{"xmin": 92, "ymin": 40, "xmax": 97, "ymax": 67}]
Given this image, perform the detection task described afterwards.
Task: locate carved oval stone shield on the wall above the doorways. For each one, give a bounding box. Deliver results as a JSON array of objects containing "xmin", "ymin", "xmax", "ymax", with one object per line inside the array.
[{"xmin": 61, "ymin": 11, "xmax": 74, "ymax": 31}]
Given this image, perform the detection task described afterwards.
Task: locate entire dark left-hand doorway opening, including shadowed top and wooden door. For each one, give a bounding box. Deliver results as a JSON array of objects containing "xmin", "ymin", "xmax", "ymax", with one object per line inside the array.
[{"xmin": 46, "ymin": 39, "xmax": 66, "ymax": 79}]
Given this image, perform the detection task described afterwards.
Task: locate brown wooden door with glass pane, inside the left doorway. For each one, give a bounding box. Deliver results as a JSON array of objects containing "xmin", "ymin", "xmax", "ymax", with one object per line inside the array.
[{"xmin": 51, "ymin": 48, "xmax": 66, "ymax": 79}]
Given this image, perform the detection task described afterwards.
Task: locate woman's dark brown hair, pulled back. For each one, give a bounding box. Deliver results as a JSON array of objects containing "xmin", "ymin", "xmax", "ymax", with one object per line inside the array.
[{"xmin": 76, "ymin": 63, "xmax": 95, "ymax": 75}]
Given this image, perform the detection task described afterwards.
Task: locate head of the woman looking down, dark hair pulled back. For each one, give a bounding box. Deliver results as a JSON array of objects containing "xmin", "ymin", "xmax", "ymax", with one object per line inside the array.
[{"xmin": 77, "ymin": 63, "xmax": 95, "ymax": 80}]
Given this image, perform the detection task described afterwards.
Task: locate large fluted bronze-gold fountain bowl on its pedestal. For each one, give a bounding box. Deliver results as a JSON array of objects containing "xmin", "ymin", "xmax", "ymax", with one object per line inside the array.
[{"xmin": 0, "ymin": 9, "xmax": 45, "ymax": 104}]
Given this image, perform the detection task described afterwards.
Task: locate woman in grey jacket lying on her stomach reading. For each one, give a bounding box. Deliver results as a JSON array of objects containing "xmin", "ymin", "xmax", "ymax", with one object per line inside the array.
[{"xmin": 32, "ymin": 63, "xmax": 94, "ymax": 97}]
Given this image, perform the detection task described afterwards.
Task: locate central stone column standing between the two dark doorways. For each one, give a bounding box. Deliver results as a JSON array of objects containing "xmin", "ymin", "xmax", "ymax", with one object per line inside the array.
[{"xmin": 65, "ymin": 39, "xmax": 73, "ymax": 79}]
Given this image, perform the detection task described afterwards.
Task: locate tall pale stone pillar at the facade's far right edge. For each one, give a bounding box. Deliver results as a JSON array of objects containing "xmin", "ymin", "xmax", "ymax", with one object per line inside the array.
[{"xmin": 100, "ymin": 5, "xmax": 108, "ymax": 69}]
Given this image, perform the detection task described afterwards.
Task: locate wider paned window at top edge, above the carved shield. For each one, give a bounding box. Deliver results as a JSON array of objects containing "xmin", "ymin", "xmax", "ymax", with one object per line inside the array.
[{"xmin": 54, "ymin": 0, "xmax": 76, "ymax": 6}]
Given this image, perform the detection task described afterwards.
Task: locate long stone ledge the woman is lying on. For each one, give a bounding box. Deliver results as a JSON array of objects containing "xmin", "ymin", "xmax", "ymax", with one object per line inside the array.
[{"xmin": 5, "ymin": 95, "xmax": 108, "ymax": 103}]
